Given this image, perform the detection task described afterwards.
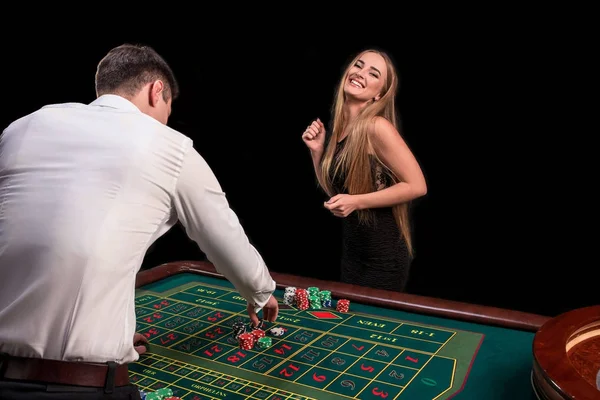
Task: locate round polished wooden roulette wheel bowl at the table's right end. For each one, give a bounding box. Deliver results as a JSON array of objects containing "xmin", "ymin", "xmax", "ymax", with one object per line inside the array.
[{"xmin": 533, "ymin": 306, "xmax": 600, "ymax": 400}]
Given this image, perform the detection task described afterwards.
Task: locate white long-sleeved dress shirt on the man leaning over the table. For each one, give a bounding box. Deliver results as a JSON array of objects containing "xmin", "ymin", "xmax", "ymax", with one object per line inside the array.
[{"xmin": 0, "ymin": 95, "xmax": 275, "ymax": 363}]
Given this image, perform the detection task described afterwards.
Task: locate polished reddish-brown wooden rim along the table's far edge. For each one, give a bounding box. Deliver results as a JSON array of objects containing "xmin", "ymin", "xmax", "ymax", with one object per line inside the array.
[{"xmin": 136, "ymin": 261, "xmax": 550, "ymax": 332}]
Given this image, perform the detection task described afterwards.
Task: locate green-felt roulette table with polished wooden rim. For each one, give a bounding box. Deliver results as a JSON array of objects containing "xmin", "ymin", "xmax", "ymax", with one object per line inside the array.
[{"xmin": 134, "ymin": 261, "xmax": 550, "ymax": 400}]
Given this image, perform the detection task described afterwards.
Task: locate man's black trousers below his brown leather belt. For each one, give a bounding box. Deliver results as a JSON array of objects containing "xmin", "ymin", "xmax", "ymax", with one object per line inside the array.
[{"xmin": 0, "ymin": 378, "xmax": 141, "ymax": 400}]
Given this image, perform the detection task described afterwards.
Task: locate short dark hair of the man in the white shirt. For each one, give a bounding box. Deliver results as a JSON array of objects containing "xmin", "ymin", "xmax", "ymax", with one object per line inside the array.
[{"xmin": 96, "ymin": 44, "xmax": 179, "ymax": 101}]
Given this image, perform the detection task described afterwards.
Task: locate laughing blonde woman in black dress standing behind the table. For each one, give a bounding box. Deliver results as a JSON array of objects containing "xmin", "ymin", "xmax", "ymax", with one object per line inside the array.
[{"xmin": 302, "ymin": 50, "xmax": 427, "ymax": 291}]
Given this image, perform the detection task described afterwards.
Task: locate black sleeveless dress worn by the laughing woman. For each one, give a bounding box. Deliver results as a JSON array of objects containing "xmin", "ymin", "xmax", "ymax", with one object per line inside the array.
[{"xmin": 331, "ymin": 139, "xmax": 411, "ymax": 292}]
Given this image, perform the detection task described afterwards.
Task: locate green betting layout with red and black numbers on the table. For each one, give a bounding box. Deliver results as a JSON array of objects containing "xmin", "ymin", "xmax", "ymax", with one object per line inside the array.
[{"xmin": 130, "ymin": 274, "xmax": 482, "ymax": 400}]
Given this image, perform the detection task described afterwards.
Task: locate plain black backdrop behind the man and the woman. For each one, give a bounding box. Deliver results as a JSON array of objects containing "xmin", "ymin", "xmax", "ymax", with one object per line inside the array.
[{"xmin": 1, "ymin": 12, "xmax": 598, "ymax": 315}]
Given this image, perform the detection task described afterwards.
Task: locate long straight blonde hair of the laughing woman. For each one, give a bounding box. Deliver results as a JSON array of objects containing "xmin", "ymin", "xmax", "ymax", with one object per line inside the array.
[{"xmin": 319, "ymin": 49, "xmax": 413, "ymax": 256}]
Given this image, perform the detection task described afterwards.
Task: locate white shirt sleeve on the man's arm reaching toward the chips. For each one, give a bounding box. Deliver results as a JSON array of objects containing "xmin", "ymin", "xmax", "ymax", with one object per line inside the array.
[{"xmin": 174, "ymin": 146, "xmax": 275, "ymax": 308}]
